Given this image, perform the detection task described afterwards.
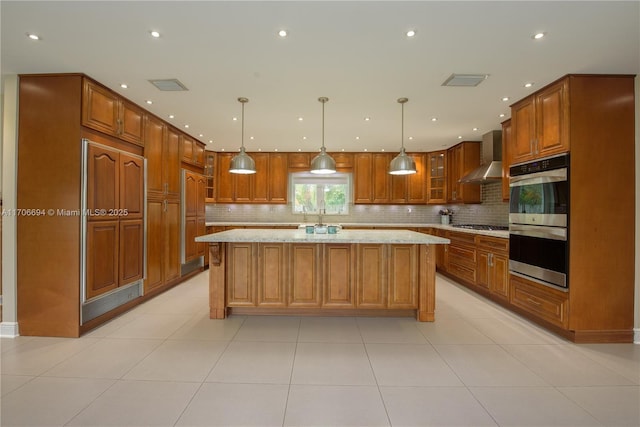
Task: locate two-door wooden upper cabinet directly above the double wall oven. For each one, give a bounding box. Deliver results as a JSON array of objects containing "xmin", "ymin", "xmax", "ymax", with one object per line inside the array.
[{"xmin": 507, "ymin": 78, "xmax": 569, "ymax": 165}]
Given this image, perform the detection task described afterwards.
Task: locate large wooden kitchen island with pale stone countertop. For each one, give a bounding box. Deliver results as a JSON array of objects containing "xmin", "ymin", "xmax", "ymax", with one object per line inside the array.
[{"xmin": 196, "ymin": 229, "xmax": 449, "ymax": 322}]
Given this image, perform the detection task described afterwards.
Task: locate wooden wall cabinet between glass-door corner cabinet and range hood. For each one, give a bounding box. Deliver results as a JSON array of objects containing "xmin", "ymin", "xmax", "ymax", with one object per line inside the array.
[{"xmin": 447, "ymin": 141, "xmax": 481, "ymax": 203}]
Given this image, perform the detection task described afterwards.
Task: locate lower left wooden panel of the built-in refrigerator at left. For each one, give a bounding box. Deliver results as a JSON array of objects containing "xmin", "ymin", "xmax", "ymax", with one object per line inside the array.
[{"xmin": 86, "ymin": 221, "xmax": 119, "ymax": 299}]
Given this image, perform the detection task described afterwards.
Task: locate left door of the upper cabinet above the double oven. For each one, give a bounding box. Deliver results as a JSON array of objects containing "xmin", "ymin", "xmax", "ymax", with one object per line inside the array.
[{"xmin": 508, "ymin": 96, "xmax": 536, "ymax": 165}]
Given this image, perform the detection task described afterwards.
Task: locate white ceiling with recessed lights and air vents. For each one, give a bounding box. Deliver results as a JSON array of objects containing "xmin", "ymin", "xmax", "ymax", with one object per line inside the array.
[{"xmin": 0, "ymin": 0, "xmax": 640, "ymax": 152}]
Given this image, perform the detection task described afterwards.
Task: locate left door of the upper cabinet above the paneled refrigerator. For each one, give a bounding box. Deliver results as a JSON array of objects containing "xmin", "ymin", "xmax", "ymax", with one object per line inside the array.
[{"xmin": 82, "ymin": 79, "xmax": 119, "ymax": 136}]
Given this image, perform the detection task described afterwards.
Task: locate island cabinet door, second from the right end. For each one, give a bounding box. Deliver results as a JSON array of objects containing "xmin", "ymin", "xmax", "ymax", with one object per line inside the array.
[{"xmin": 356, "ymin": 244, "xmax": 388, "ymax": 308}]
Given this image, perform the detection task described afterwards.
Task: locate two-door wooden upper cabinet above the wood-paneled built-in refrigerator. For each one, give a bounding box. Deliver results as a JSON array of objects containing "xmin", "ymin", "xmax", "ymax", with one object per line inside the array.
[{"xmin": 82, "ymin": 78, "xmax": 145, "ymax": 146}]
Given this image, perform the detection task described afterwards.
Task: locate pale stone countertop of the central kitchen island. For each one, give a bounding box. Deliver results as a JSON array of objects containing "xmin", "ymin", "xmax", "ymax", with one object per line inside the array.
[{"xmin": 196, "ymin": 229, "xmax": 450, "ymax": 245}]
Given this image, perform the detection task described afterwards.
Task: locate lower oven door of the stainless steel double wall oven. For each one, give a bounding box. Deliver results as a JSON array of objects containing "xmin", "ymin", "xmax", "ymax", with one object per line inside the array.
[{"xmin": 509, "ymin": 224, "xmax": 569, "ymax": 288}]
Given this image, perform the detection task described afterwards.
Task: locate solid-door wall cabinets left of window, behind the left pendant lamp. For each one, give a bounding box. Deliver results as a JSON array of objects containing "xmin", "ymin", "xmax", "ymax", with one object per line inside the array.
[{"xmin": 215, "ymin": 153, "xmax": 289, "ymax": 204}]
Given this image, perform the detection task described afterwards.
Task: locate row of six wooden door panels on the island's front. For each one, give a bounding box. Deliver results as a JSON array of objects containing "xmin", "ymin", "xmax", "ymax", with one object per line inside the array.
[{"xmin": 226, "ymin": 242, "xmax": 420, "ymax": 310}]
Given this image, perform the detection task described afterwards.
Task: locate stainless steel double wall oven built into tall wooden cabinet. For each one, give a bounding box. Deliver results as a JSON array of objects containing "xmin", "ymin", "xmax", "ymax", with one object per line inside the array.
[{"xmin": 509, "ymin": 154, "xmax": 569, "ymax": 290}]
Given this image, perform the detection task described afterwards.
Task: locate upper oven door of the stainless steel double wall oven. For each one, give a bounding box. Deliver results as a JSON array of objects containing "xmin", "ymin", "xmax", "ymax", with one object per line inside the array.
[{"xmin": 509, "ymin": 168, "xmax": 569, "ymax": 227}]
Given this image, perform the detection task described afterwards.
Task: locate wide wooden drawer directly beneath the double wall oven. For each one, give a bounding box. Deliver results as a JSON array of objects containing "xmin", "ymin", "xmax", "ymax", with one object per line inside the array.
[{"xmin": 510, "ymin": 275, "xmax": 569, "ymax": 328}]
